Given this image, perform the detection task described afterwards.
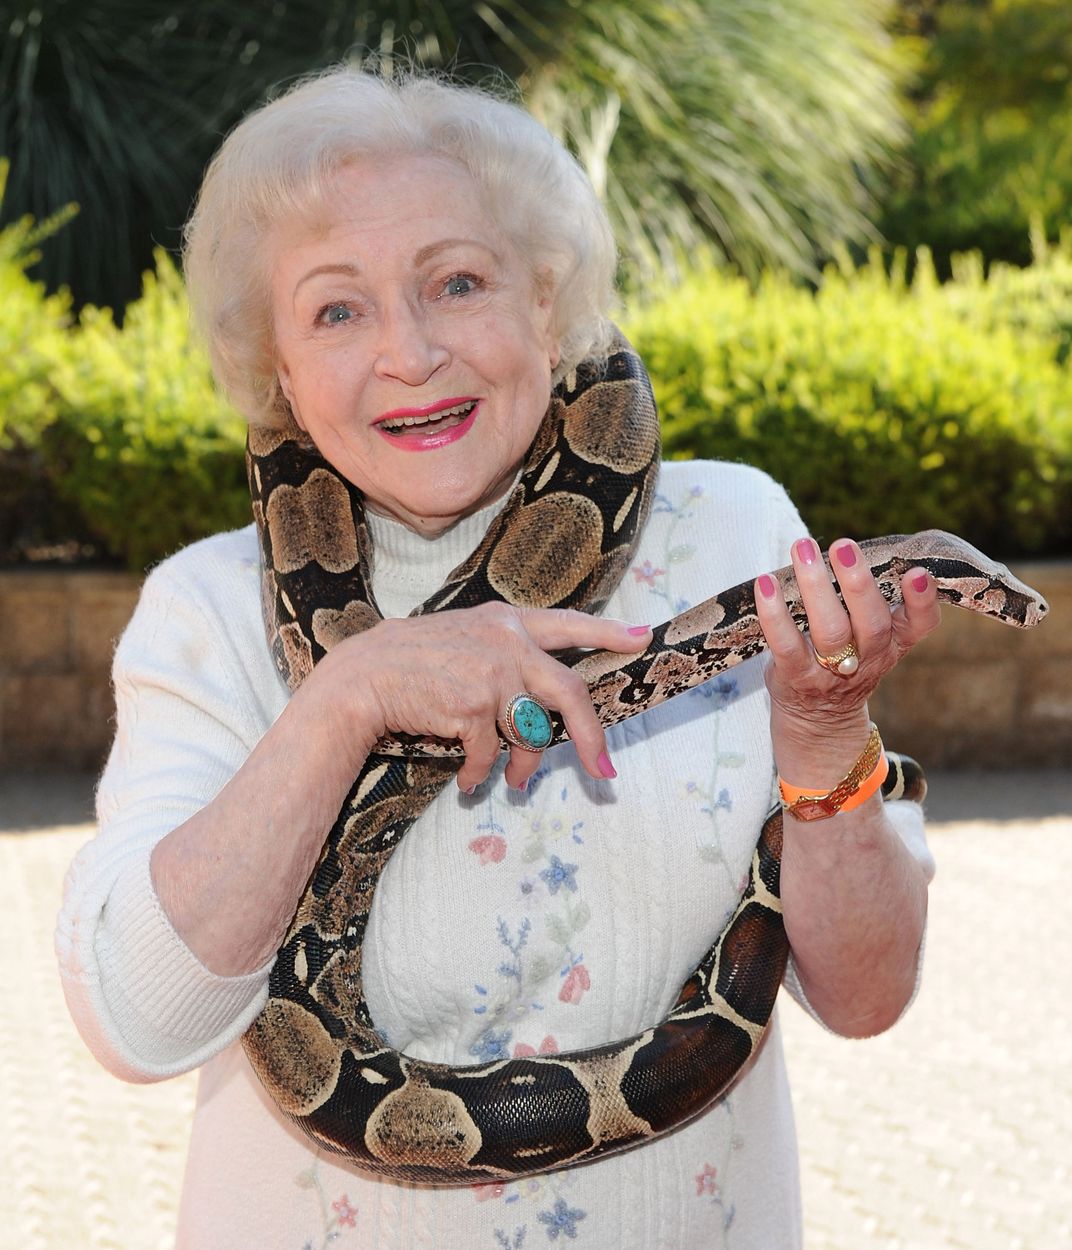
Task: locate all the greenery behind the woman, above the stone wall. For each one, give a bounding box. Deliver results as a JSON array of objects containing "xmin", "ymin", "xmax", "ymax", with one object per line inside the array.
[{"xmin": 0, "ymin": 0, "xmax": 1072, "ymax": 569}]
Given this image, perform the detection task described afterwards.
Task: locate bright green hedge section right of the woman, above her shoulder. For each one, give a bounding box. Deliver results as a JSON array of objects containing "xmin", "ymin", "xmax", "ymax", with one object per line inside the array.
[{"xmin": 625, "ymin": 258, "xmax": 1072, "ymax": 555}]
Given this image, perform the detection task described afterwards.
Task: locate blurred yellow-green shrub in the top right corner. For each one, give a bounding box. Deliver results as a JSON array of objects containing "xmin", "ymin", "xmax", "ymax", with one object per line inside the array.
[{"xmin": 878, "ymin": 0, "xmax": 1072, "ymax": 276}]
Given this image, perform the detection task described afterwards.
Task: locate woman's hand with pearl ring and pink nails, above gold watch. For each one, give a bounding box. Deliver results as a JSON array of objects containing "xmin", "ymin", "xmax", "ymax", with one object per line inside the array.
[{"xmin": 756, "ymin": 539, "xmax": 940, "ymax": 785}]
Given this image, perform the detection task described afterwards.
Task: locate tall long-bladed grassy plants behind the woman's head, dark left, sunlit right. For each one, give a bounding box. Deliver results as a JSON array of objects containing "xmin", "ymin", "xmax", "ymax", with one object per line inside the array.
[{"xmin": 0, "ymin": 0, "xmax": 901, "ymax": 310}]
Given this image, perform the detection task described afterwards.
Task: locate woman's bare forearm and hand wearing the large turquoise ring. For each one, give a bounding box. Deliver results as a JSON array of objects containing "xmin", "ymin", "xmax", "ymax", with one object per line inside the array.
[{"xmin": 152, "ymin": 604, "xmax": 650, "ymax": 976}]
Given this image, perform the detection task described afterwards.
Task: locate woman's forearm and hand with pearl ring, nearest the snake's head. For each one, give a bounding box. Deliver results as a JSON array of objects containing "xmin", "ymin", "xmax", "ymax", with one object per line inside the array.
[{"xmin": 756, "ymin": 539, "xmax": 940, "ymax": 1036}]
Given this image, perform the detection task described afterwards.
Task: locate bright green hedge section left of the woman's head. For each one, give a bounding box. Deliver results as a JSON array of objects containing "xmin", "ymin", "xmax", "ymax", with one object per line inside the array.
[{"xmin": 0, "ymin": 223, "xmax": 250, "ymax": 570}]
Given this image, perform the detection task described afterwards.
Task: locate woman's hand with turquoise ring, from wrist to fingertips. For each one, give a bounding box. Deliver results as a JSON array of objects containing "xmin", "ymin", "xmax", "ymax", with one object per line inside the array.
[{"xmin": 304, "ymin": 603, "xmax": 651, "ymax": 793}]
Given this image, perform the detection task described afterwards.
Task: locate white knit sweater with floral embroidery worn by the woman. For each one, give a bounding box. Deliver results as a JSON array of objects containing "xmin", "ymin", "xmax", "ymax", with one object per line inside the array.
[{"xmin": 56, "ymin": 463, "xmax": 932, "ymax": 1250}]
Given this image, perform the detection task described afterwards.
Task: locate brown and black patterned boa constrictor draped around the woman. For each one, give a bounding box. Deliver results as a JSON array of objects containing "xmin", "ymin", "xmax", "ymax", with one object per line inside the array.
[{"xmin": 244, "ymin": 330, "xmax": 1046, "ymax": 1184}]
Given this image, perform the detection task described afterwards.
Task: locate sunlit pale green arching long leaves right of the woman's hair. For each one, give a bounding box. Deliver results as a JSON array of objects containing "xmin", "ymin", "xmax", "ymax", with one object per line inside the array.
[{"xmin": 509, "ymin": 0, "xmax": 901, "ymax": 279}]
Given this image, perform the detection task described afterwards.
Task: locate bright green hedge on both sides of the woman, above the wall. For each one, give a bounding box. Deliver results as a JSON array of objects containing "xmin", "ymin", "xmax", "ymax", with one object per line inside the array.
[{"xmin": 0, "ymin": 228, "xmax": 1072, "ymax": 569}]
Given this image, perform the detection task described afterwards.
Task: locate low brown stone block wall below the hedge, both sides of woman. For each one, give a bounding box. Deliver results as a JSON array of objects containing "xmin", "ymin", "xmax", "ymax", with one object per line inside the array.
[{"xmin": 0, "ymin": 563, "xmax": 1072, "ymax": 771}]
